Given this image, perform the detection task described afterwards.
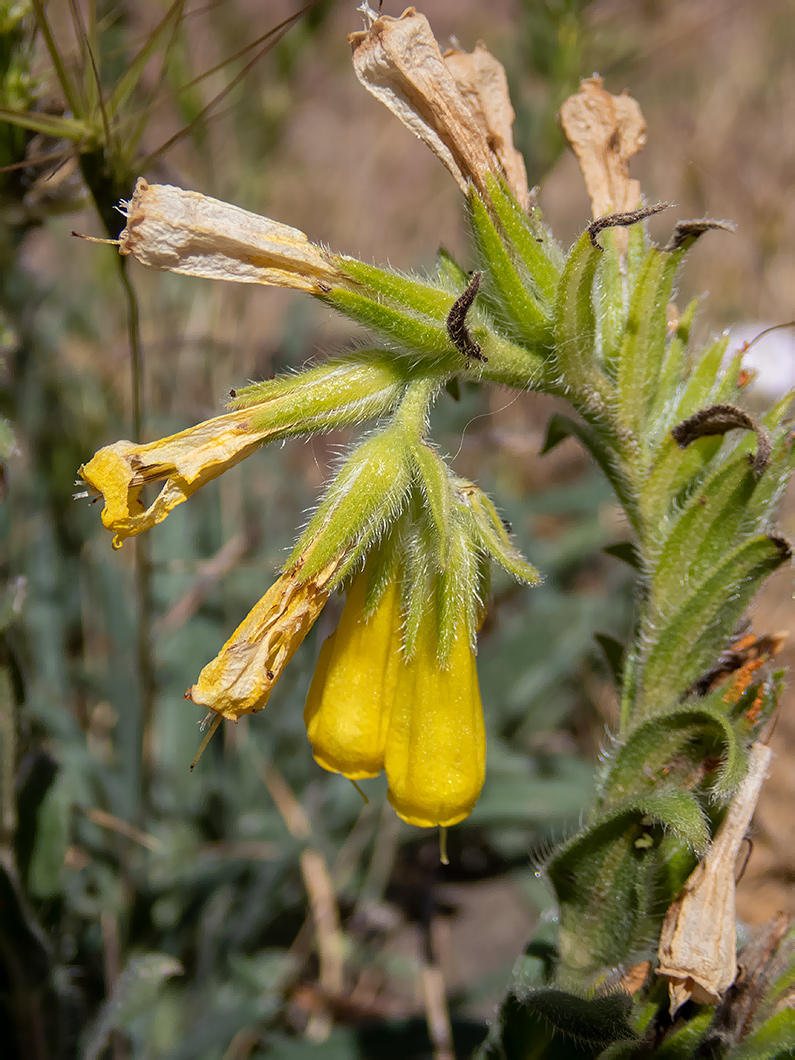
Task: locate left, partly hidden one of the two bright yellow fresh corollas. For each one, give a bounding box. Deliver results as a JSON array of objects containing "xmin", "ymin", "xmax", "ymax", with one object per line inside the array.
[{"xmin": 303, "ymin": 575, "xmax": 402, "ymax": 780}]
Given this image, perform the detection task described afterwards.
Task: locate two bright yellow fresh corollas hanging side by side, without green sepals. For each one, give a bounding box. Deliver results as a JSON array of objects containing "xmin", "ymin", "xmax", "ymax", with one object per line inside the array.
[{"xmin": 304, "ymin": 573, "xmax": 485, "ymax": 828}]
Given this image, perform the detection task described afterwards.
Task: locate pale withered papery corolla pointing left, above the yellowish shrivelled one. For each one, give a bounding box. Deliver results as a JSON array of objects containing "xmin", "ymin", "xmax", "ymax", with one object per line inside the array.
[{"xmin": 119, "ymin": 177, "xmax": 345, "ymax": 294}]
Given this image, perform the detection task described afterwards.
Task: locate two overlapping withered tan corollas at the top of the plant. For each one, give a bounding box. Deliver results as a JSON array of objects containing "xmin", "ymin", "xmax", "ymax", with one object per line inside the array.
[{"xmin": 348, "ymin": 7, "xmax": 530, "ymax": 207}]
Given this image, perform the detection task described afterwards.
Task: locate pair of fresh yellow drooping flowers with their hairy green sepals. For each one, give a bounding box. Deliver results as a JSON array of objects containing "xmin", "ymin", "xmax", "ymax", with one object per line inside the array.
[{"xmin": 304, "ymin": 442, "xmax": 538, "ymax": 828}]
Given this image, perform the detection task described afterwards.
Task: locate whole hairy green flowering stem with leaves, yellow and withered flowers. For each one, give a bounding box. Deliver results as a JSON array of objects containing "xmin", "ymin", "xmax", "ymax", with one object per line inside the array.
[{"xmin": 81, "ymin": 8, "xmax": 795, "ymax": 1058}]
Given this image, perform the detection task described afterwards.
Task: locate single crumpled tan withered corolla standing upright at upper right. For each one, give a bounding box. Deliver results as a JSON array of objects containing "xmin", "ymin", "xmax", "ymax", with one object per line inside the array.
[{"xmin": 561, "ymin": 77, "xmax": 646, "ymax": 217}]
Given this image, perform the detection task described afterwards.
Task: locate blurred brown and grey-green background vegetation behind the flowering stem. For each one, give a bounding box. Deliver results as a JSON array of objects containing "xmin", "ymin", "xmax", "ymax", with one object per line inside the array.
[{"xmin": 0, "ymin": 0, "xmax": 795, "ymax": 1060}]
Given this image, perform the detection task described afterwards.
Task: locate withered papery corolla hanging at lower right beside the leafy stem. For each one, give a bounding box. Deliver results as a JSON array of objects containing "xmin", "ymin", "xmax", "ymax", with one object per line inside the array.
[{"xmin": 657, "ymin": 743, "xmax": 771, "ymax": 1015}]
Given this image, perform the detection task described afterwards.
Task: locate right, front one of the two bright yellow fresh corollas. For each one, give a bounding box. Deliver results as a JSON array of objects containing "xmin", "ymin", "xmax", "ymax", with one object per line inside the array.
[{"xmin": 384, "ymin": 615, "xmax": 485, "ymax": 828}]
